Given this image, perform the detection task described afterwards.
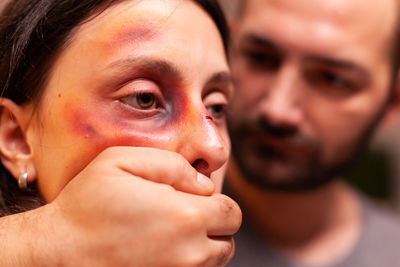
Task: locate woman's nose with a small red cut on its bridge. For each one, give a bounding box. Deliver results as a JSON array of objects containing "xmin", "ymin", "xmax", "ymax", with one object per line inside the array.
[{"xmin": 177, "ymin": 109, "xmax": 230, "ymax": 177}]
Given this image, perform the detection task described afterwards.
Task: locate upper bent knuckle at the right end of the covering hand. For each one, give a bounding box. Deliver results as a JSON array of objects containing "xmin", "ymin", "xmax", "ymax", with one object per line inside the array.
[{"xmin": 198, "ymin": 194, "xmax": 242, "ymax": 237}]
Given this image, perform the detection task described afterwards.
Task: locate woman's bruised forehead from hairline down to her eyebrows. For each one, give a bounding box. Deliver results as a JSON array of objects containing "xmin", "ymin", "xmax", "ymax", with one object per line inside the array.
[{"xmin": 57, "ymin": 0, "xmax": 228, "ymax": 79}]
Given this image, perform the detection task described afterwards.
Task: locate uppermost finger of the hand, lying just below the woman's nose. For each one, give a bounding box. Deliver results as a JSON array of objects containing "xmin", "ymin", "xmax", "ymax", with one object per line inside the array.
[{"xmin": 98, "ymin": 147, "xmax": 215, "ymax": 196}]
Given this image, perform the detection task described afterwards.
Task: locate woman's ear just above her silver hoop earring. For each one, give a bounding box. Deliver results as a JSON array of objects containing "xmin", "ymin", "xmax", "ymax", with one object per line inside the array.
[{"xmin": 0, "ymin": 98, "xmax": 36, "ymax": 185}]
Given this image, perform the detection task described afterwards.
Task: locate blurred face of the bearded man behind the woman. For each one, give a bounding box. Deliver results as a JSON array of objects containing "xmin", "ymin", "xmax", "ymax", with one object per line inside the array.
[{"xmin": 229, "ymin": 0, "xmax": 397, "ymax": 189}]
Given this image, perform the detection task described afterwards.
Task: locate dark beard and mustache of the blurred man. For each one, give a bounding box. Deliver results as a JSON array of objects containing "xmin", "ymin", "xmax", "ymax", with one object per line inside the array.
[{"xmin": 229, "ymin": 105, "xmax": 386, "ymax": 192}]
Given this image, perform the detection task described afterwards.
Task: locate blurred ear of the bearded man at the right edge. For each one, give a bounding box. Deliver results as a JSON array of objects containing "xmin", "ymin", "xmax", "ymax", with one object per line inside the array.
[{"xmin": 381, "ymin": 70, "xmax": 400, "ymax": 128}]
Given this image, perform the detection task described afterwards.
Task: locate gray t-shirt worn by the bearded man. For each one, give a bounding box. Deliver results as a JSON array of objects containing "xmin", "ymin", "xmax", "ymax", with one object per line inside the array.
[{"xmin": 227, "ymin": 197, "xmax": 400, "ymax": 267}]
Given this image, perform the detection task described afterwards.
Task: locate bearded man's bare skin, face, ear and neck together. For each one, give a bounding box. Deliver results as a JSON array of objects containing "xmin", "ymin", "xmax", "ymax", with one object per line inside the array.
[{"xmin": 227, "ymin": 0, "xmax": 398, "ymax": 266}]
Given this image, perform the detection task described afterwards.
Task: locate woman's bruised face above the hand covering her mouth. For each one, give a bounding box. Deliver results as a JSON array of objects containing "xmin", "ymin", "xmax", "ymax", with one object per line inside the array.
[{"xmin": 27, "ymin": 0, "xmax": 232, "ymax": 201}]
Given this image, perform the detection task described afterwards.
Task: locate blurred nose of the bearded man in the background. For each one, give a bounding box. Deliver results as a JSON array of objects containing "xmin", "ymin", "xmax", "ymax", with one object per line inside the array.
[{"xmin": 261, "ymin": 64, "xmax": 303, "ymax": 128}]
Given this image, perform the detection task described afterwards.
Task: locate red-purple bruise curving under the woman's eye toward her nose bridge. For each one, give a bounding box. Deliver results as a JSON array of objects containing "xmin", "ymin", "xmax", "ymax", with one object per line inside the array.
[{"xmin": 64, "ymin": 88, "xmax": 202, "ymax": 151}]
